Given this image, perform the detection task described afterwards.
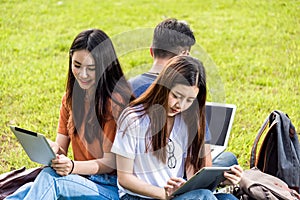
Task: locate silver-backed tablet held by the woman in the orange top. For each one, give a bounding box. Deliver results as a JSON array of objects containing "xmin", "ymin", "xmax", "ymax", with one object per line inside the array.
[{"xmin": 10, "ymin": 126, "xmax": 55, "ymax": 166}]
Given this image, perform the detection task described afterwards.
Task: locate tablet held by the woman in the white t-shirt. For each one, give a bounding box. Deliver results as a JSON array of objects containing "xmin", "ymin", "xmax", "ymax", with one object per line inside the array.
[{"xmin": 172, "ymin": 167, "xmax": 230, "ymax": 196}]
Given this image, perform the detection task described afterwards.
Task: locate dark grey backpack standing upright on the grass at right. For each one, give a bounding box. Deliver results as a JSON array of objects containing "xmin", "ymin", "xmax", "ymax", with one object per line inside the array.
[{"xmin": 250, "ymin": 110, "xmax": 300, "ymax": 192}]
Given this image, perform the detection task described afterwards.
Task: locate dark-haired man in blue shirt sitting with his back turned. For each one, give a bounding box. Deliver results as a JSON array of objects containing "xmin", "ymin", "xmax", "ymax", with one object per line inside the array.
[{"xmin": 129, "ymin": 18, "xmax": 238, "ymax": 167}]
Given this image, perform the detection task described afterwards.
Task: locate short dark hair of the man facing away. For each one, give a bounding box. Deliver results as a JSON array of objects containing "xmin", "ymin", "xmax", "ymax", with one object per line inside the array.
[{"xmin": 152, "ymin": 18, "xmax": 196, "ymax": 58}]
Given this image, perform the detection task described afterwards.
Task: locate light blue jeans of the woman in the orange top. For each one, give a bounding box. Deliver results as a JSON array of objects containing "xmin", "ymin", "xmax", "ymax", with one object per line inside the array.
[{"xmin": 6, "ymin": 167, "xmax": 119, "ymax": 200}]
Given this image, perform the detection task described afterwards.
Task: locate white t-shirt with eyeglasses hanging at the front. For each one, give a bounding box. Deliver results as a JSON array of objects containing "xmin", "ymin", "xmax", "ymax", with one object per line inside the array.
[{"xmin": 111, "ymin": 106, "xmax": 188, "ymax": 198}]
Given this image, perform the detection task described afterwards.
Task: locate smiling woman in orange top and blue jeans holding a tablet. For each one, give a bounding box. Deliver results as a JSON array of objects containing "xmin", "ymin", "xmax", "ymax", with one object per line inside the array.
[{"xmin": 7, "ymin": 29, "xmax": 132, "ymax": 199}]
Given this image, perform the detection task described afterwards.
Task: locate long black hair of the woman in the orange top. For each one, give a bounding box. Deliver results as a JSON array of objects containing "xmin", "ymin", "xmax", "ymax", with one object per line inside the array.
[{"xmin": 66, "ymin": 29, "xmax": 132, "ymax": 143}]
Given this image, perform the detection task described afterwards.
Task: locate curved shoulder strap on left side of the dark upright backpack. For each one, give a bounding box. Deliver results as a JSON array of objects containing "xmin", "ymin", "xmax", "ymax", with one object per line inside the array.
[{"xmin": 250, "ymin": 111, "xmax": 277, "ymax": 168}]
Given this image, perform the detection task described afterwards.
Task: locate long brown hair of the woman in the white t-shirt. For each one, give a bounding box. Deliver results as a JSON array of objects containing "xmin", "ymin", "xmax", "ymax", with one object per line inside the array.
[{"xmin": 122, "ymin": 56, "xmax": 206, "ymax": 171}]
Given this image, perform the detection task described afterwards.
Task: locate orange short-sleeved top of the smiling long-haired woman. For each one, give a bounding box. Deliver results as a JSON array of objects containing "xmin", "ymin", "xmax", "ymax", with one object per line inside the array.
[{"xmin": 57, "ymin": 94, "xmax": 116, "ymax": 161}]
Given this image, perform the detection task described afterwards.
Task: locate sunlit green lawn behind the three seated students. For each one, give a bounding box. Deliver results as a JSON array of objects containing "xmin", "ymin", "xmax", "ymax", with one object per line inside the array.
[{"xmin": 0, "ymin": 0, "xmax": 300, "ymax": 173}]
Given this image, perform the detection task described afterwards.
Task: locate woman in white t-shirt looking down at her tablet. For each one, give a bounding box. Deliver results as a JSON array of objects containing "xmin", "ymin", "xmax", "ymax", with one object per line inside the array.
[{"xmin": 112, "ymin": 56, "xmax": 242, "ymax": 200}]
